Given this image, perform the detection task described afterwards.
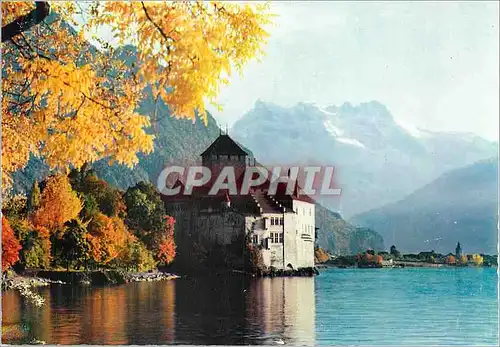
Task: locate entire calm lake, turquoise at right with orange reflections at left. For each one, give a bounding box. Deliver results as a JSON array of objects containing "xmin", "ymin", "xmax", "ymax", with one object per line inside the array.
[{"xmin": 2, "ymin": 268, "xmax": 498, "ymax": 345}]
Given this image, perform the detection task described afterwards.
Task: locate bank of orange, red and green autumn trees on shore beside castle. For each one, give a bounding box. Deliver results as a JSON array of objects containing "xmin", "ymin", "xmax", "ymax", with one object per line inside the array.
[{"xmin": 2, "ymin": 172, "xmax": 176, "ymax": 271}]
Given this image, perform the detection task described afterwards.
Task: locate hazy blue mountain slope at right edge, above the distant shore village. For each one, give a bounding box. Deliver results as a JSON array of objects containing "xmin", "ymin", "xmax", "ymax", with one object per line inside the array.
[{"xmin": 352, "ymin": 157, "xmax": 498, "ymax": 254}]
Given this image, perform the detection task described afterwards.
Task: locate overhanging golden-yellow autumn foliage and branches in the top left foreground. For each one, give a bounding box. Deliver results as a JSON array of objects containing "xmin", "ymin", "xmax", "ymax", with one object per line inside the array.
[{"xmin": 2, "ymin": 1, "xmax": 270, "ymax": 186}]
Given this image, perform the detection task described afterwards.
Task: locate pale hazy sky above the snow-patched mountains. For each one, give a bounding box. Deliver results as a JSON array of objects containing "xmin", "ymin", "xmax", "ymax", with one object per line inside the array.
[{"xmin": 213, "ymin": 1, "xmax": 499, "ymax": 140}]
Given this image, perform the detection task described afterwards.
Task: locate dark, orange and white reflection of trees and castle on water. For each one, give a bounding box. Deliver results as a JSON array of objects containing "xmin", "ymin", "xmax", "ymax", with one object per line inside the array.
[{"xmin": 2, "ymin": 277, "xmax": 315, "ymax": 345}]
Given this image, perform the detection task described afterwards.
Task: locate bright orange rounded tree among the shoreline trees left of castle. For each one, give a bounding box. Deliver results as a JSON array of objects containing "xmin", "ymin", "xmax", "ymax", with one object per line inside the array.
[{"xmin": 33, "ymin": 174, "xmax": 82, "ymax": 232}]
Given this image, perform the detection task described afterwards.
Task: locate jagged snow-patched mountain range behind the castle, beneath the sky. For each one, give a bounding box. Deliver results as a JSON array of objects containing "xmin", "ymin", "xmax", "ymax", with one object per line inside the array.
[{"xmin": 231, "ymin": 101, "xmax": 498, "ymax": 217}]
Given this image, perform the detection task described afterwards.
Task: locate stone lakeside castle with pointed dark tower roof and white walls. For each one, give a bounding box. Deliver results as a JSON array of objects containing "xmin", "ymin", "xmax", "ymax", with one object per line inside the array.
[{"xmin": 163, "ymin": 133, "xmax": 316, "ymax": 270}]
